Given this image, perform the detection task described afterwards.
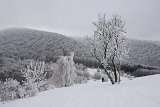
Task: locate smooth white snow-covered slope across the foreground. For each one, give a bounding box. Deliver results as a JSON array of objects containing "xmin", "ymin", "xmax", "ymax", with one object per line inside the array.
[{"xmin": 0, "ymin": 75, "xmax": 160, "ymax": 107}]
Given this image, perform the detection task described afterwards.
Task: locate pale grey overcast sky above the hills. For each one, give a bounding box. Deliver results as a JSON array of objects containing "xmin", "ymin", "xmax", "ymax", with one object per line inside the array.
[{"xmin": 0, "ymin": 0, "xmax": 160, "ymax": 41}]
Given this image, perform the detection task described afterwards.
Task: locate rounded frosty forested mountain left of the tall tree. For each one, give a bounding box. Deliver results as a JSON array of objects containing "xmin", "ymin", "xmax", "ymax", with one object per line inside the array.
[{"xmin": 0, "ymin": 28, "xmax": 89, "ymax": 59}]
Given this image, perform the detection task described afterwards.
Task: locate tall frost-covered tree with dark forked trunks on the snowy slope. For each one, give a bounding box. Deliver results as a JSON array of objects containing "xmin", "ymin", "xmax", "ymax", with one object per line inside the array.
[{"xmin": 87, "ymin": 14, "xmax": 128, "ymax": 84}]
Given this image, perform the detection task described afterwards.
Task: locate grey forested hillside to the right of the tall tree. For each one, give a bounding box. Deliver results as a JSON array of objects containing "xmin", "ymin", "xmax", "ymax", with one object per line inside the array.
[{"xmin": 128, "ymin": 39, "xmax": 160, "ymax": 67}]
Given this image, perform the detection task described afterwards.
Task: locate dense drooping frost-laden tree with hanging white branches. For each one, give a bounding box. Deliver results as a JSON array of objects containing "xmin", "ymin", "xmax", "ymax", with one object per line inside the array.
[{"xmin": 52, "ymin": 52, "xmax": 76, "ymax": 87}]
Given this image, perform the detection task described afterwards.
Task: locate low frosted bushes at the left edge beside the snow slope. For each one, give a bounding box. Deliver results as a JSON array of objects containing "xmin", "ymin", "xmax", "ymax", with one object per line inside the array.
[{"xmin": 0, "ymin": 78, "xmax": 42, "ymax": 101}]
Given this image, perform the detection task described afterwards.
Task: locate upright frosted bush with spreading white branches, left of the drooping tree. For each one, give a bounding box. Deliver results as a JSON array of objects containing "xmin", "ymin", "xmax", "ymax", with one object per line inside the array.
[{"xmin": 21, "ymin": 61, "xmax": 46, "ymax": 97}]
